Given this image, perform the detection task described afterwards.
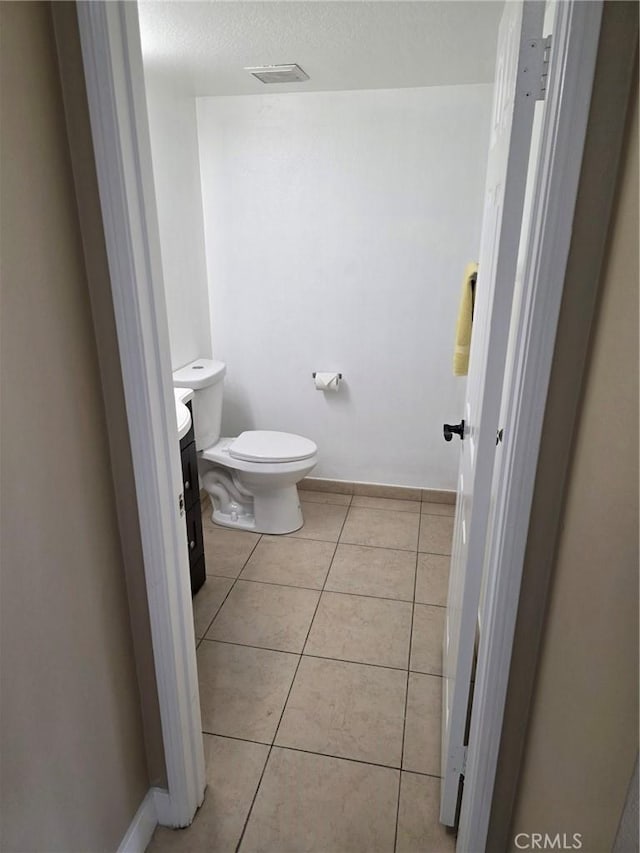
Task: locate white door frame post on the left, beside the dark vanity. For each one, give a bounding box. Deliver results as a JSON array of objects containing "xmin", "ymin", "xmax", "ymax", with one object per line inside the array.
[{"xmin": 76, "ymin": 0, "xmax": 205, "ymax": 827}]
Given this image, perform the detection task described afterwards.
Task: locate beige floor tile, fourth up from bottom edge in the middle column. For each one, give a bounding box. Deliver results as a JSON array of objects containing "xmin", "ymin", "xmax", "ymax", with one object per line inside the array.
[{"xmin": 324, "ymin": 545, "xmax": 416, "ymax": 601}]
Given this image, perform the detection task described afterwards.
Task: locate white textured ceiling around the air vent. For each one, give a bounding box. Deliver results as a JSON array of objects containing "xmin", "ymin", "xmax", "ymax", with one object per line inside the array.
[{"xmin": 138, "ymin": 0, "xmax": 503, "ymax": 96}]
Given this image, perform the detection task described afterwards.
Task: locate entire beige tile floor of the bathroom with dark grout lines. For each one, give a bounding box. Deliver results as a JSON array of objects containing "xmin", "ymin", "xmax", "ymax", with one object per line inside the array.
[{"xmin": 148, "ymin": 491, "xmax": 455, "ymax": 853}]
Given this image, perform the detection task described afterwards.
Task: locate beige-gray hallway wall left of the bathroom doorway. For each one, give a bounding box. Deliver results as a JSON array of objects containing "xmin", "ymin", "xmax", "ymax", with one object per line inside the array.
[{"xmin": 0, "ymin": 3, "xmax": 149, "ymax": 853}]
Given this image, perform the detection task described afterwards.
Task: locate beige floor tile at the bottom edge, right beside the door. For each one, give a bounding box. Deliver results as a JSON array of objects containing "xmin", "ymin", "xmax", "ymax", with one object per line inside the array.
[{"xmin": 396, "ymin": 771, "xmax": 456, "ymax": 853}]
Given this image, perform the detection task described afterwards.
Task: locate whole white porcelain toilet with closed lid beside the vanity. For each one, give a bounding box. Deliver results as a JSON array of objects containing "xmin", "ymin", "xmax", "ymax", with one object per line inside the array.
[{"xmin": 173, "ymin": 358, "xmax": 318, "ymax": 533}]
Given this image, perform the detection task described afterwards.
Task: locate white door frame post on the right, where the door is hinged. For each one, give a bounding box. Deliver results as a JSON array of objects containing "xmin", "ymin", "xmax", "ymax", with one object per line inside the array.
[{"xmin": 456, "ymin": 0, "xmax": 602, "ymax": 853}]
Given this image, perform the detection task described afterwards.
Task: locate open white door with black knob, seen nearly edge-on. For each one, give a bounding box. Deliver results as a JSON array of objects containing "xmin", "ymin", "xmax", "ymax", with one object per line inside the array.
[{"xmin": 440, "ymin": 2, "xmax": 544, "ymax": 826}]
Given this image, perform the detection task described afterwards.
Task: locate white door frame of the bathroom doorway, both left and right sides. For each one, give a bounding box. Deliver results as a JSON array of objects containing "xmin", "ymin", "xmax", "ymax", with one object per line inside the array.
[{"xmin": 77, "ymin": 0, "xmax": 602, "ymax": 851}]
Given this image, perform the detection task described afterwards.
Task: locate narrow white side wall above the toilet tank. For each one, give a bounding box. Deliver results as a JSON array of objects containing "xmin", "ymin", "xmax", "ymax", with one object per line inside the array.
[{"xmin": 145, "ymin": 74, "xmax": 211, "ymax": 370}]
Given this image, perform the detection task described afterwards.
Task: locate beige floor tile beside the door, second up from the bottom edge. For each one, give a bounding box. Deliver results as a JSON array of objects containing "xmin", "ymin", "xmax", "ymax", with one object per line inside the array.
[{"xmin": 402, "ymin": 672, "xmax": 442, "ymax": 776}]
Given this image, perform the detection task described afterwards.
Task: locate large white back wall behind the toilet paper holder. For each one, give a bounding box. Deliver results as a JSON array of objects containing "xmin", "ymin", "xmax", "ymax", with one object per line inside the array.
[{"xmin": 197, "ymin": 84, "xmax": 492, "ymax": 489}]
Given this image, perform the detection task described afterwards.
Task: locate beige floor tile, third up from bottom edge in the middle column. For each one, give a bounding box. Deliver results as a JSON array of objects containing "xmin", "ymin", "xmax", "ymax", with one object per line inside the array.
[{"xmin": 306, "ymin": 592, "xmax": 412, "ymax": 669}]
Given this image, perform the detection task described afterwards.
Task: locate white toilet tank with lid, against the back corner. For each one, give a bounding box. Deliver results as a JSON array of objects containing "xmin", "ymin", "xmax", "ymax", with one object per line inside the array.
[{"xmin": 173, "ymin": 358, "xmax": 227, "ymax": 450}]
